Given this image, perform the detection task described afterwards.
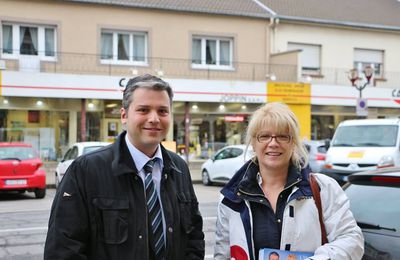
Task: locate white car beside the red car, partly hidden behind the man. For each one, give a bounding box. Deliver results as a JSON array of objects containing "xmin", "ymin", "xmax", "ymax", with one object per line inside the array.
[{"xmin": 55, "ymin": 142, "xmax": 110, "ymax": 188}]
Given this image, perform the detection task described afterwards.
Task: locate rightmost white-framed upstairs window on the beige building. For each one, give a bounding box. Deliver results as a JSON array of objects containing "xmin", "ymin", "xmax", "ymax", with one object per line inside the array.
[{"xmin": 192, "ymin": 36, "xmax": 233, "ymax": 69}]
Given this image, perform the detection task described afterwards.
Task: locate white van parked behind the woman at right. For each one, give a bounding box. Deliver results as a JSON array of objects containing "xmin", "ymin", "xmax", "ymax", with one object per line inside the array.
[{"xmin": 322, "ymin": 118, "xmax": 400, "ymax": 184}]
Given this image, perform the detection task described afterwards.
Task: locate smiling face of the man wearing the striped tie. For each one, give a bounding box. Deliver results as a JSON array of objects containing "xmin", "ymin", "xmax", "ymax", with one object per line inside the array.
[{"xmin": 121, "ymin": 88, "xmax": 171, "ymax": 157}]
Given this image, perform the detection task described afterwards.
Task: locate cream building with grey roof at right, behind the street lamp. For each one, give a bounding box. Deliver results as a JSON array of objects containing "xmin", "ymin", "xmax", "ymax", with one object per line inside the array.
[{"xmin": 260, "ymin": 0, "xmax": 400, "ymax": 139}]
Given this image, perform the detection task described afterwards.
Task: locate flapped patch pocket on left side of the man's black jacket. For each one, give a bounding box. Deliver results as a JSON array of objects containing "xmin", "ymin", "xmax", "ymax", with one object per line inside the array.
[{"xmin": 93, "ymin": 198, "xmax": 129, "ymax": 244}]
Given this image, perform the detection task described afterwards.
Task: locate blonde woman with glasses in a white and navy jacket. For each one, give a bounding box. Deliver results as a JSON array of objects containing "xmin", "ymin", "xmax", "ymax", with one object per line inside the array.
[{"xmin": 214, "ymin": 103, "xmax": 364, "ymax": 260}]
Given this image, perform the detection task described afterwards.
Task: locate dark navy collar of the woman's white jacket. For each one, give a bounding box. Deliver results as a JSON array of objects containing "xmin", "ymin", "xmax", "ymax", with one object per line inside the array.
[{"xmin": 221, "ymin": 160, "xmax": 312, "ymax": 203}]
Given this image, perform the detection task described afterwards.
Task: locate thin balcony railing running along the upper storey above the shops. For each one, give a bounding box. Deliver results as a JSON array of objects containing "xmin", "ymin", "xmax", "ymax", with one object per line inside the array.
[{"xmin": 0, "ymin": 53, "xmax": 400, "ymax": 88}]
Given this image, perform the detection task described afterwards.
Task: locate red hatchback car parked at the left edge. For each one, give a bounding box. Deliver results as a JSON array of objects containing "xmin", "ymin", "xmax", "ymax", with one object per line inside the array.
[{"xmin": 0, "ymin": 143, "xmax": 46, "ymax": 199}]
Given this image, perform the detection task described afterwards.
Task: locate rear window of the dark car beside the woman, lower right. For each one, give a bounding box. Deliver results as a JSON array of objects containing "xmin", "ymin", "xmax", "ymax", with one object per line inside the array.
[{"xmin": 345, "ymin": 184, "xmax": 400, "ymax": 234}]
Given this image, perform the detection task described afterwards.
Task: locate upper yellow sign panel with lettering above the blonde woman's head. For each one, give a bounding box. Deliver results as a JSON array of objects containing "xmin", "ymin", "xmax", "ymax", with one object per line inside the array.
[{"xmin": 267, "ymin": 82, "xmax": 311, "ymax": 104}]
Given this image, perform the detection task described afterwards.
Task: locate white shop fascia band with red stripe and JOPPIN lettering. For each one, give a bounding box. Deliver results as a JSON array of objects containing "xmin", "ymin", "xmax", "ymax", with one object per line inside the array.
[{"xmin": 0, "ymin": 71, "xmax": 400, "ymax": 108}]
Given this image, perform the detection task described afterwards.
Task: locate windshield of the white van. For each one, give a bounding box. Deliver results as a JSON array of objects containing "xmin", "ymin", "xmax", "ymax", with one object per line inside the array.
[{"xmin": 332, "ymin": 125, "xmax": 398, "ymax": 147}]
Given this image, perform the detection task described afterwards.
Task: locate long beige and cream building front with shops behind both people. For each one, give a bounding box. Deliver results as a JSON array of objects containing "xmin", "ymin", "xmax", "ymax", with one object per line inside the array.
[{"xmin": 0, "ymin": 0, "xmax": 400, "ymax": 160}]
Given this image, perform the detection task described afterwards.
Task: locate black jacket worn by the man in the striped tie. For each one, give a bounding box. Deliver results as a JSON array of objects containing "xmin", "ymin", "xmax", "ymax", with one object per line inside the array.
[{"xmin": 44, "ymin": 132, "xmax": 204, "ymax": 260}]
